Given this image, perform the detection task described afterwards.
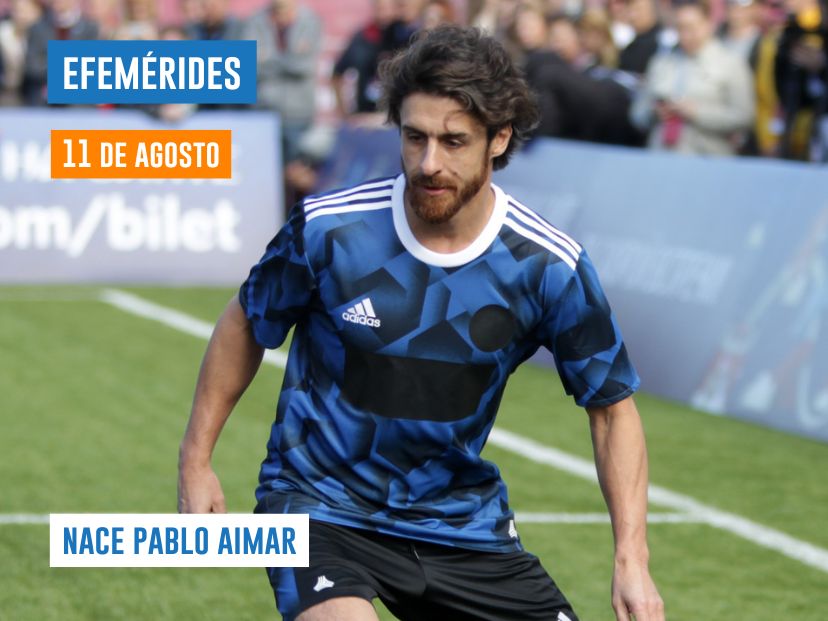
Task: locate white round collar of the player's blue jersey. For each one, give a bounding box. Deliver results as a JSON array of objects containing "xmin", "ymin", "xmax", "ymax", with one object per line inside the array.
[{"xmin": 391, "ymin": 174, "xmax": 506, "ymax": 267}]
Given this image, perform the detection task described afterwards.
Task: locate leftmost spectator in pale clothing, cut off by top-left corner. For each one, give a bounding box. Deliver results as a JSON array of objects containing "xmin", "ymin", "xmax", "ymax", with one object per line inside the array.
[{"xmin": 0, "ymin": 0, "xmax": 42, "ymax": 106}]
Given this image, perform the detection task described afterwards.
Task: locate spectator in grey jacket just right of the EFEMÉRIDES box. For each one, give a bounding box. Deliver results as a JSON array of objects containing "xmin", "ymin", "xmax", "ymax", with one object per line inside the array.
[{"xmin": 245, "ymin": 0, "xmax": 322, "ymax": 163}]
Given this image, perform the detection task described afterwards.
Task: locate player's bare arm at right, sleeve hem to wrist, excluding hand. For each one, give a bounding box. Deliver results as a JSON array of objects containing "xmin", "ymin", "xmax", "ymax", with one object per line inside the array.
[{"xmin": 588, "ymin": 398, "xmax": 649, "ymax": 563}]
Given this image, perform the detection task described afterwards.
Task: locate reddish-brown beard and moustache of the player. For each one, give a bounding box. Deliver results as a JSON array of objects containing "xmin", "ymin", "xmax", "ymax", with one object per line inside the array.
[{"xmin": 403, "ymin": 153, "xmax": 488, "ymax": 224}]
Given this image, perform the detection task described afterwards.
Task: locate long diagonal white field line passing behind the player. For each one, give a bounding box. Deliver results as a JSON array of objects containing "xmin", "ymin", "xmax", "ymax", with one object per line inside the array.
[{"xmin": 95, "ymin": 289, "xmax": 828, "ymax": 573}]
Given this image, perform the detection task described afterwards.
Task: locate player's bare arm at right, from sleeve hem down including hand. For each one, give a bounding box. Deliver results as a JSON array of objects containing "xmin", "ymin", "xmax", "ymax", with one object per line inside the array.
[{"xmin": 587, "ymin": 397, "xmax": 664, "ymax": 621}]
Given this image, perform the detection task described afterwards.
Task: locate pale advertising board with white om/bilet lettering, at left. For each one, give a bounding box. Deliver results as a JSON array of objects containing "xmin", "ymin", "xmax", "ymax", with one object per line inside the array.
[{"xmin": 0, "ymin": 109, "xmax": 284, "ymax": 286}]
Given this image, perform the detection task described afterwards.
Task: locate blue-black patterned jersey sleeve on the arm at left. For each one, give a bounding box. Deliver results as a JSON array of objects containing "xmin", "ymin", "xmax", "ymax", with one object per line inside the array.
[{"xmin": 239, "ymin": 204, "xmax": 316, "ymax": 348}]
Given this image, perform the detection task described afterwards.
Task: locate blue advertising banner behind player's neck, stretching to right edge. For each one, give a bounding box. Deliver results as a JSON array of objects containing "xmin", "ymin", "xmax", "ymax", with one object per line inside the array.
[{"xmin": 312, "ymin": 129, "xmax": 828, "ymax": 440}]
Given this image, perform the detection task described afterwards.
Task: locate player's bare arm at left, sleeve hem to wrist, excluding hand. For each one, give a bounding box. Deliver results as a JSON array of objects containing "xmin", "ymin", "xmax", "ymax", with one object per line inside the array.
[{"xmin": 179, "ymin": 297, "xmax": 264, "ymax": 467}]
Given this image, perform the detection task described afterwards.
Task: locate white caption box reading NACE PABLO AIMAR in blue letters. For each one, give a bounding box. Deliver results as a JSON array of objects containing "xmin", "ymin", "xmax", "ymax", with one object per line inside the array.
[{"xmin": 49, "ymin": 513, "xmax": 309, "ymax": 567}]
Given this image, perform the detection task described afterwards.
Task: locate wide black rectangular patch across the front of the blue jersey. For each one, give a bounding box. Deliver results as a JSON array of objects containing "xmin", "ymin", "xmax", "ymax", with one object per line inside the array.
[{"xmin": 342, "ymin": 344, "xmax": 495, "ymax": 422}]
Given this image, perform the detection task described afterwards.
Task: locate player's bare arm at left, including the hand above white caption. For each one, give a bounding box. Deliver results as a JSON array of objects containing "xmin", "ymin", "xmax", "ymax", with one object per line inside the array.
[{"xmin": 178, "ymin": 296, "xmax": 264, "ymax": 513}]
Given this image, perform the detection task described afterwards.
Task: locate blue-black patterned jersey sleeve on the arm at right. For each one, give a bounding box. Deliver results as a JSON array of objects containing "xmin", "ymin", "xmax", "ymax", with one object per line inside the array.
[{"xmin": 541, "ymin": 251, "xmax": 641, "ymax": 407}]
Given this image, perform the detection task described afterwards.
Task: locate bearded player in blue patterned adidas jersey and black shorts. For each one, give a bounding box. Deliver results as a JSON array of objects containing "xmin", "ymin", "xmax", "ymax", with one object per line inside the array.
[{"xmin": 179, "ymin": 26, "xmax": 664, "ymax": 621}]
